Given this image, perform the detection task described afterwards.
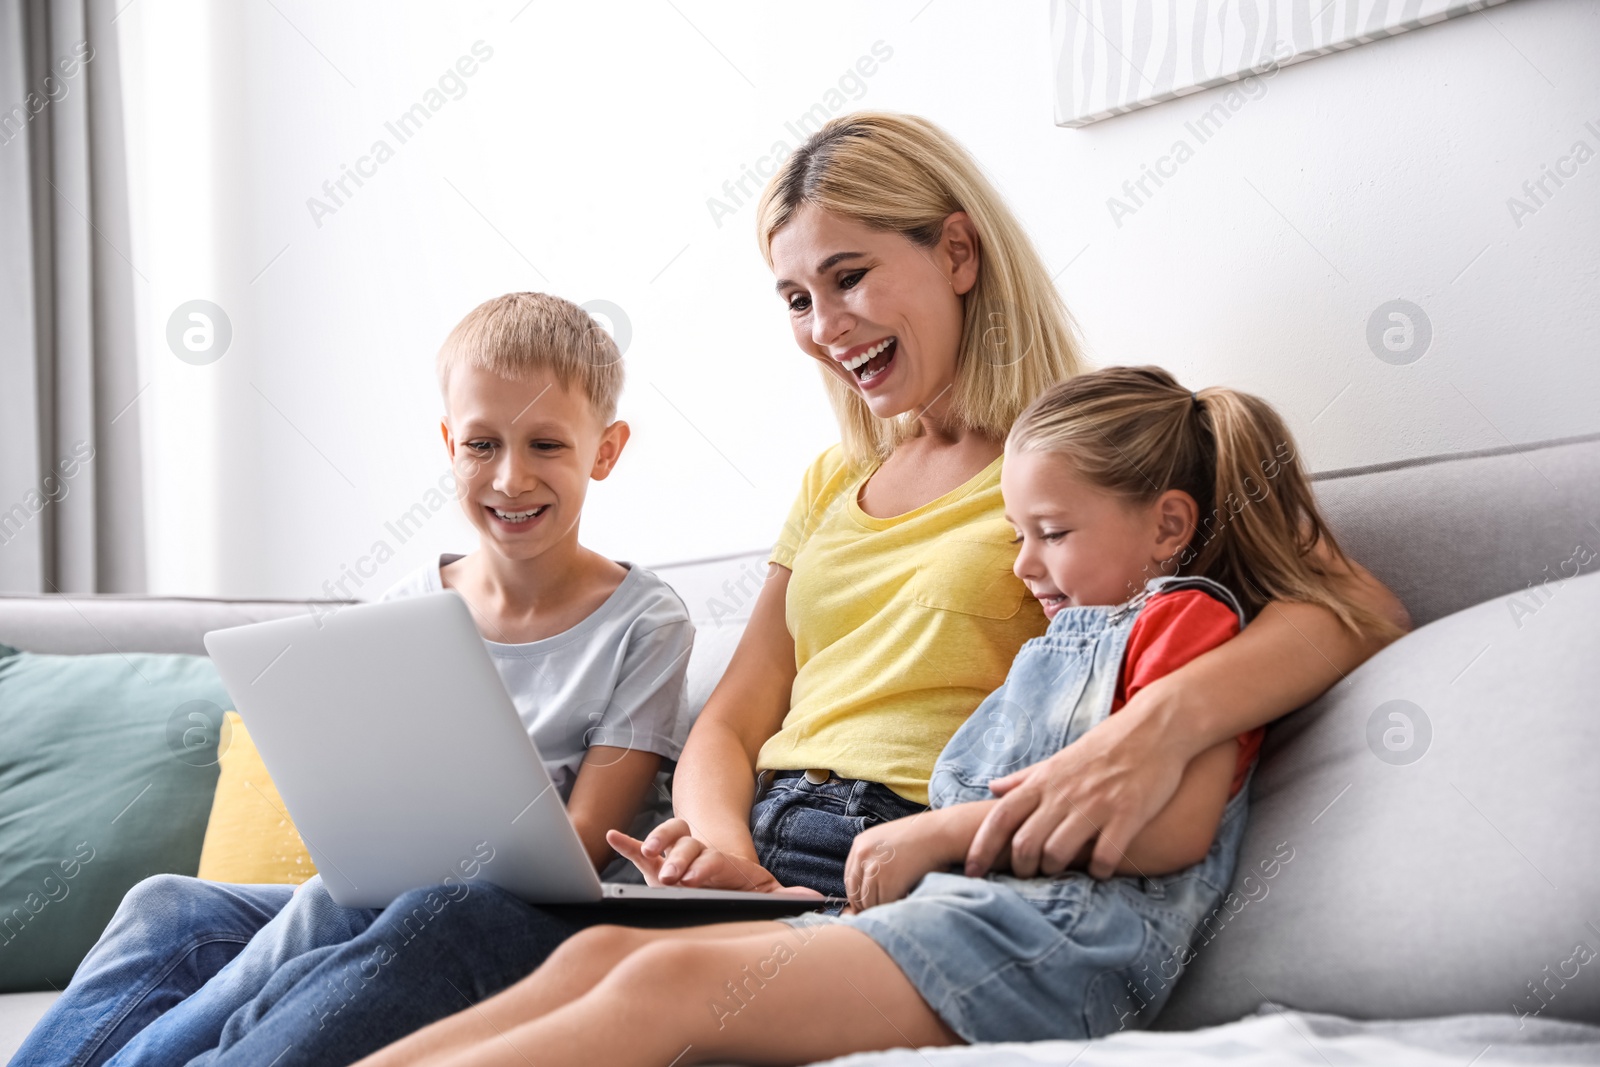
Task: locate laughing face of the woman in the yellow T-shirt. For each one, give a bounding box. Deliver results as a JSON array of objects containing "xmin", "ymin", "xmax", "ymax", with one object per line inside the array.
[{"xmin": 771, "ymin": 205, "xmax": 978, "ymax": 419}]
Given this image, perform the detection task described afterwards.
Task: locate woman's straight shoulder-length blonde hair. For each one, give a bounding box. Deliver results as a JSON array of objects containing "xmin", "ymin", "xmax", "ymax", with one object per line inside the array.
[{"xmin": 757, "ymin": 112, "xmax": 1082, "ymax": 464}]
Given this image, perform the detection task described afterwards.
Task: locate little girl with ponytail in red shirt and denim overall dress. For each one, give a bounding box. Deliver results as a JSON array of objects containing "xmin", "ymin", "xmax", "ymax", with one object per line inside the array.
[{"xmin": 350, "ymin": 368, "xmax": 1395, "ymax": 1067}]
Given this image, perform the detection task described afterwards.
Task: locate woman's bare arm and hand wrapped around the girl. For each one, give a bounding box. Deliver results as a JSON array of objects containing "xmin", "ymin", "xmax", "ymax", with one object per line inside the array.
[{"xmin": 966, "ymin": 547, "xmax": 1410, "ymax": 878}]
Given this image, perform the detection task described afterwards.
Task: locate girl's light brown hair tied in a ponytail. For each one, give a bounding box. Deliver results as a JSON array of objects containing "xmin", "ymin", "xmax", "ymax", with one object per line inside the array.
[{"xmin": 1006, "ymin": 366, "xmax": 1402, "ymax": 640}]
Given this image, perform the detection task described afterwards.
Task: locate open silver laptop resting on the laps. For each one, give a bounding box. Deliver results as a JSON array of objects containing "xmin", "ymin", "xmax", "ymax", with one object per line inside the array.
[{"xmin": 205, "ymin": 590, "xmax": 842, "ymax": 918}]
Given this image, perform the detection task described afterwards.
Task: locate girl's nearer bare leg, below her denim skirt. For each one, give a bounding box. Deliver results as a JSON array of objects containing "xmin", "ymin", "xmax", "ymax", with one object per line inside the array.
[{"xmin": 426, "ymin": 923, "xmax": 962, "ymax": 1067}]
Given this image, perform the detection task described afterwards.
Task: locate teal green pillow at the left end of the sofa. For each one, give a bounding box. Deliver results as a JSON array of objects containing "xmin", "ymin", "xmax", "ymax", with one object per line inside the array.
[{"xmin": 0, "ymin": 645, "xmax": 230, "ymax": 992}]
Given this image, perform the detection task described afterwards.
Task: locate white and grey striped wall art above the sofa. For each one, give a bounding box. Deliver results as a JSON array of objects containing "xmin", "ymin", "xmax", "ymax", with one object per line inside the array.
[{"xmin": 1050, "ymin": 0, "xmax": 1507, "ymax": 126}]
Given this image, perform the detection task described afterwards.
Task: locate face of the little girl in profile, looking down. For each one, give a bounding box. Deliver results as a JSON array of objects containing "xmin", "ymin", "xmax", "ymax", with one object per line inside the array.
[{"xmin": 1000, "ymin": 450, "xmax": 1198, "ymax": 619}]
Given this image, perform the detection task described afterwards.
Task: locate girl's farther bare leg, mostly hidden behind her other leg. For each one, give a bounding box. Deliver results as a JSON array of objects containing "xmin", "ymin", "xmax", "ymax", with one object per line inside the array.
[{"xmin": 357, "ymin": 921, "xmax": 782, "ymax": 1067}]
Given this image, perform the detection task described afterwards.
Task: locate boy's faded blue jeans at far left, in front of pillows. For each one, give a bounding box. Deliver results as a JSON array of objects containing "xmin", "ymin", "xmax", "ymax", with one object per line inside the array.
[{"xmin": 11, "ymin": 875, "xmax": 376, "ymax": 1067}]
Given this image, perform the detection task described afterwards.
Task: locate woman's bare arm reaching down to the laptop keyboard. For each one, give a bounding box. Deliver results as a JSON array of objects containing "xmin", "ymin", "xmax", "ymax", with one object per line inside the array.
[{"xmin": 643, "ymin": 563, "xmax": 795, "ymax": 889}]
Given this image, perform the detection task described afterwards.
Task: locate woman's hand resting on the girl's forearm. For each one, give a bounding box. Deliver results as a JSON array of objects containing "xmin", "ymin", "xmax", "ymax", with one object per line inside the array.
[{"xmin": 966, "ymin": 704, "xmax": 1189, "ymax": 878}]
